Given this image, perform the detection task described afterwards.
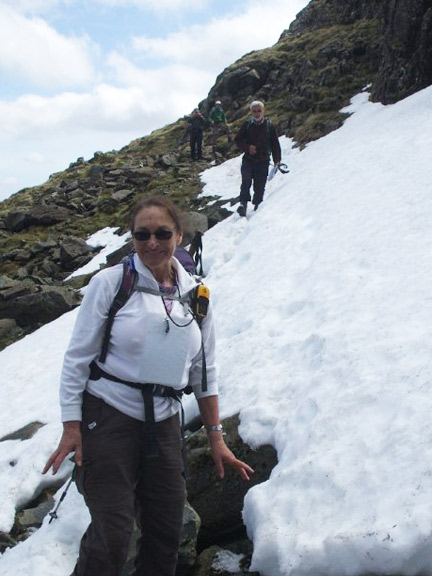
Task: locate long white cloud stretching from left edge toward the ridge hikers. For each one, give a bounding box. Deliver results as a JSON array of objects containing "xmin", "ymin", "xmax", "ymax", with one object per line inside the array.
[{"xmin": 0, "ymin": 64, "xmax": 208, "ymax": 142}]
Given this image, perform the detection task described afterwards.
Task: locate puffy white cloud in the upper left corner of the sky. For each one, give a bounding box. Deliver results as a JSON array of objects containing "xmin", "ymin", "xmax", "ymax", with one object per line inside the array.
[{"xmin": 0, "ymin": 5, "xmax": 96, "ymax": 89}]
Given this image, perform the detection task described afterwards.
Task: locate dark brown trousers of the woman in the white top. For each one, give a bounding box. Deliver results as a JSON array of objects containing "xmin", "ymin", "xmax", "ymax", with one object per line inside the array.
[{"xmin": 72, "ymin": 392, "xmax": 186, "ymax": 576}]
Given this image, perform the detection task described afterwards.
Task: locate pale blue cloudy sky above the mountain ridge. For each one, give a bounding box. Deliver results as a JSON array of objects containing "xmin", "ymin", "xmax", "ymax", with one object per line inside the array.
[{"xmin": 0, "ymin": 0, "xmax": 309, "ymax": 201}]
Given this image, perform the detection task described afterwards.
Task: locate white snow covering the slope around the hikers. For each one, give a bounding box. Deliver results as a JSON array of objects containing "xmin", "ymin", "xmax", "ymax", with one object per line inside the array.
[{"xmin": 0, "ymin": 87, "xmax": 432, "ymax": 576}]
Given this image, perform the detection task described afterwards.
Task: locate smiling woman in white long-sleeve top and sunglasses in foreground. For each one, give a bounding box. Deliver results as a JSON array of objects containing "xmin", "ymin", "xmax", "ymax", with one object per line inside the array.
[{"xmin": 43, "ymin": 197, "xmax": 253, "ymax": 576}]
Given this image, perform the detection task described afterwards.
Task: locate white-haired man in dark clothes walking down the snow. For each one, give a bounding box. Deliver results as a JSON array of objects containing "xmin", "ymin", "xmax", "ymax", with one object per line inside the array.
[{"xmin": 234, "ymin": 100, "xmax": 281, "ymax": 216}]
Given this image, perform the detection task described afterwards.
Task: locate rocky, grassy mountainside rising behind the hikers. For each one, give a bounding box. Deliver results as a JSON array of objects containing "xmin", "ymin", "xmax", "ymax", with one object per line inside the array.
[{"xmin": 0, "ymin": 0, "xmax": 432, "ymax": 348}]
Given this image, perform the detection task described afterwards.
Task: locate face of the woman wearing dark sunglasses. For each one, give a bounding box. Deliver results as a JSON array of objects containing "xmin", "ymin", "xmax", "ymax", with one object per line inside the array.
[{"xmin": 133, "ymin": 206, "xmax": 182, "ymax": 271}]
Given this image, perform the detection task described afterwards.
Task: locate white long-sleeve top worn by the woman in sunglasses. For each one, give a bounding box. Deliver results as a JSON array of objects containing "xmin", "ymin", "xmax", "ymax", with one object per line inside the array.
[{"xmin": 60, "ymin": 254, "xmax": 218, "ymax": 422}]
